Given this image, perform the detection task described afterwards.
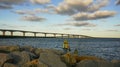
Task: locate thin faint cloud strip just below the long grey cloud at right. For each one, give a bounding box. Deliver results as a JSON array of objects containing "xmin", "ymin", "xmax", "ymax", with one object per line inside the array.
[{"xmin": 57, "ymin": 22, "xmax": 97, "ymax": 27}]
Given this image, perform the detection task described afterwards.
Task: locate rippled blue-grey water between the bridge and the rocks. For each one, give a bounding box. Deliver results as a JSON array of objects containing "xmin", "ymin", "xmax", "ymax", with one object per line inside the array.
[{"xmin": 0, "ymin": 38, "xmax": 120, "ymax": 60}]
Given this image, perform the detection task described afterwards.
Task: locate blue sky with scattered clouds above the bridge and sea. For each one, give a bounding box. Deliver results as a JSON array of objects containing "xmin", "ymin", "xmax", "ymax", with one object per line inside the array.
[{"xmin": 0, "ymin": 0, "xmax": 120, "ymax": 38}]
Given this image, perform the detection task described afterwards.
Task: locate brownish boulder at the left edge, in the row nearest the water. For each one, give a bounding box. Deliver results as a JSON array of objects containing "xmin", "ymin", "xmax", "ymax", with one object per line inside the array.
[{"xmin": 0, "ymin": 45, "xmax": 20, "ymax": 53}]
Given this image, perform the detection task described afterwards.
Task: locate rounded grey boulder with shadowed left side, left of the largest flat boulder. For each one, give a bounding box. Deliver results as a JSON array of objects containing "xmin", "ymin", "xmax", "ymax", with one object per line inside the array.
[{"xmin": 10, "ymin": 51, "xmax": 30, "ymax": 66}]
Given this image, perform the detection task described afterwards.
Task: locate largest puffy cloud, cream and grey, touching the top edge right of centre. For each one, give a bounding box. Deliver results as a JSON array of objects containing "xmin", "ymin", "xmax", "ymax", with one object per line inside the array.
[{"xmin": 55, "ymin": 0, "xmax": 109, "ymax": 15}]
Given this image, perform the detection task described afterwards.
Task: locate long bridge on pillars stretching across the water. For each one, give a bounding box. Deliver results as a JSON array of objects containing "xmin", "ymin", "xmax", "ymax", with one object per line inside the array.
[{"xmin": 0, "ymin": 29, "xmax": 92, "ymax": 38}]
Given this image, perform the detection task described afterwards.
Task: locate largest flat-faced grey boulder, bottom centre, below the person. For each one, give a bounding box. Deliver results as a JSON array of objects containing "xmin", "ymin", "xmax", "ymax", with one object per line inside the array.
[{"xmin": 39, "ymin": 51, "xmax": 66, "ymax": 67}]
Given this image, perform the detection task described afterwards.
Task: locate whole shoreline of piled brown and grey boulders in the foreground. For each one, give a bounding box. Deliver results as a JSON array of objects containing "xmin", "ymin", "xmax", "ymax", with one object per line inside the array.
[{"xmin": 0, "ymin": 45, "xmax": 120, "ymax": 67}]
